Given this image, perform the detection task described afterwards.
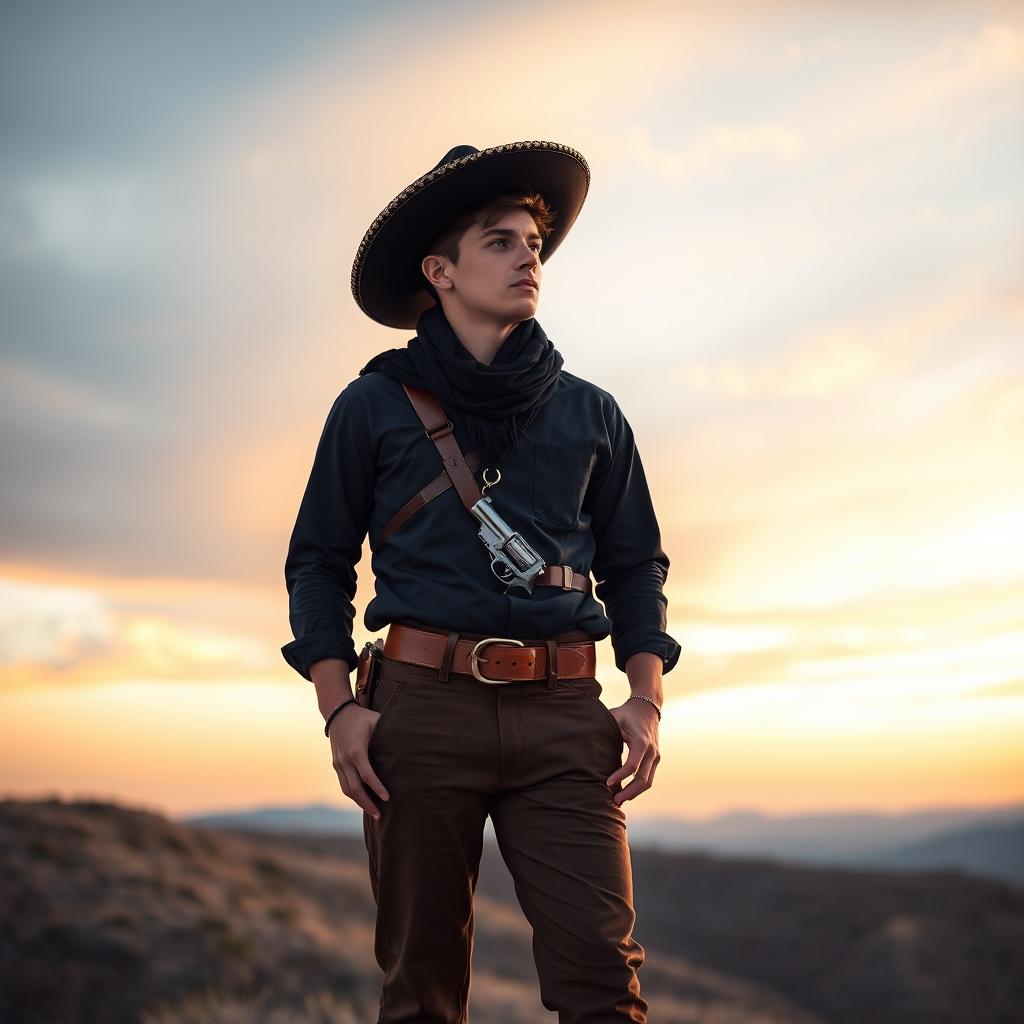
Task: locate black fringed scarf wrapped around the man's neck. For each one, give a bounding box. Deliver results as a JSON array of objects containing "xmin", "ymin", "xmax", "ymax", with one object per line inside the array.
[{"xmin": 359, "ymin": 303, "xmax": 563, "ymax": 466}]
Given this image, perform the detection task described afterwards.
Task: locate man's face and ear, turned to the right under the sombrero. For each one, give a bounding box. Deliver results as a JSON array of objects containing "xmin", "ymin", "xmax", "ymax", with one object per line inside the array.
[{"xmin": 424, "ymin": 210, "xmax": 543, "ymax": 325}]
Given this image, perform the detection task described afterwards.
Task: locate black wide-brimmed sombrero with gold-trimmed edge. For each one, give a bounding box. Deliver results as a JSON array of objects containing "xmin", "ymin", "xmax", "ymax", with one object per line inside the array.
[{"xmin": 352, "ymin": 142, "xmax": 590, "ymax": 329}]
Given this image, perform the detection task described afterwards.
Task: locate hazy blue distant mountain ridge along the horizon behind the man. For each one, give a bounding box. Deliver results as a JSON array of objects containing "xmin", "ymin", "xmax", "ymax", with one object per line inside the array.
[{"xmin": 188, "ymin": 804, "xmax": 1024, "ymax": 886}]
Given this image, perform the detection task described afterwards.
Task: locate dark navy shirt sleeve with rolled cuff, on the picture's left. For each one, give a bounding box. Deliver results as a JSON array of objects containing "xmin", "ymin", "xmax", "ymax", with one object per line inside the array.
[{"xmin": 281, "ymin": 381, "xmax": 375, "ymax": 681}]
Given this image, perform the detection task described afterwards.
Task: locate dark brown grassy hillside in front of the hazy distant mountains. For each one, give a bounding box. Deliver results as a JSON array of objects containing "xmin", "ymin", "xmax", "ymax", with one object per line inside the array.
[{"xmin": 0, "ymin": 800, "xmax": 1024, "ymax": 1024}]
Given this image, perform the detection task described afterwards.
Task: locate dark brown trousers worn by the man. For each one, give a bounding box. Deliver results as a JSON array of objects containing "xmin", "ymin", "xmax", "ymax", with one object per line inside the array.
[{"xmin": 362, "ymin": 634, "xmax": 647, "ymax": 1024}]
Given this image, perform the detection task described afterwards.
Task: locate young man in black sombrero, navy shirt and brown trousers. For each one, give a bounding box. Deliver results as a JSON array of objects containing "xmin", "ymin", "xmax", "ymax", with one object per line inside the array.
[{"xmin": 282, "ymin": 142, "xmax": 680, "ymax": 1024}]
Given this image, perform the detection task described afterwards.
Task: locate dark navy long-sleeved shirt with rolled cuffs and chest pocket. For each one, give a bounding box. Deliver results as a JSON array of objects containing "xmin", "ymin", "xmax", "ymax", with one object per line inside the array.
[{"xmin": 282, "ymin": 368, "xmax": 680, "ymax": 679}]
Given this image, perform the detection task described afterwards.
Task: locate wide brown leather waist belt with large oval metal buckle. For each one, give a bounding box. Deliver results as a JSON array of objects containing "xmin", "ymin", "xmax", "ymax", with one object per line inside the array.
[{"xmin": 384, "ymin": 623, "xmax": 597, "ymax": 689}]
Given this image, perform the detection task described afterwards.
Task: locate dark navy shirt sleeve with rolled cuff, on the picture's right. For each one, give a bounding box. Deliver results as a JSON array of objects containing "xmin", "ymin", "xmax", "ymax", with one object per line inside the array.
[{"xmin": 585, "ymin": 395, "xmax": 681, "ymax": 673}]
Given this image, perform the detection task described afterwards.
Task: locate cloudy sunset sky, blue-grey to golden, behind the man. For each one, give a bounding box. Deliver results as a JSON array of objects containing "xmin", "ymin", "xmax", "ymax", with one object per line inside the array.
[{"xmin": 0, "ymin": 0, "xmax": 1024, "ymax": 817}]
